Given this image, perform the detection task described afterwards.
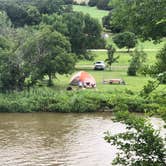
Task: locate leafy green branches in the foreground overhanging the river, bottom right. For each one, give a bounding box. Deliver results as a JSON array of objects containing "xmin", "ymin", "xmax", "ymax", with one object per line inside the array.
[{"xmin": 104, "ymin": 111, "xmax": 166, "ymax": 166}]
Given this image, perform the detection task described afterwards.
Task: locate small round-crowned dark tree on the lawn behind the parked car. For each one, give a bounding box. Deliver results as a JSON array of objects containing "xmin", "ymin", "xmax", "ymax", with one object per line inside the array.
[{"xmin": 113, "ymin": 32, "xmax": 137, "ymax": 52}]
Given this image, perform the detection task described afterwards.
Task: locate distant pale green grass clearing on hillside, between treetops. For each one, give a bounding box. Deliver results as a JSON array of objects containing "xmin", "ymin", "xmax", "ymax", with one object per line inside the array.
[{"xmin": 73, "ymin": 5, "xmax": 109, "ymax": 23}]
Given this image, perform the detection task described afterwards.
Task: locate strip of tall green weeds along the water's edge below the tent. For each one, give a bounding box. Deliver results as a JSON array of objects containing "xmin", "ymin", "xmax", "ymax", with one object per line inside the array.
[{"xmin": 0, "ymin": 87, "xmax": 166, "ymax": 112}]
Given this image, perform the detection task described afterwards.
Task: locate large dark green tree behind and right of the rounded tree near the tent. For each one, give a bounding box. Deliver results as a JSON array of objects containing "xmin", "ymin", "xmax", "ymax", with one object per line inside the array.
[{"xmin": 41, "ymin": 12, "xmax": 105, "ymax": 57}]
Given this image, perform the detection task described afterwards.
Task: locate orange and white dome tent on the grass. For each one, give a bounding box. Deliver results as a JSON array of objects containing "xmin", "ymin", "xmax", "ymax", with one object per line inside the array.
[{"xmin": 70, "ymin": 71, "xmax": 96, "ymax": 87}]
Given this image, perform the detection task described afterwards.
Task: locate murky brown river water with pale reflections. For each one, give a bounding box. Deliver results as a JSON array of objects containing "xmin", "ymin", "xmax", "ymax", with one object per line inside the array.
[{"xmin": 0, "ymin": 113, "xmax": 165, "ymax": 166}]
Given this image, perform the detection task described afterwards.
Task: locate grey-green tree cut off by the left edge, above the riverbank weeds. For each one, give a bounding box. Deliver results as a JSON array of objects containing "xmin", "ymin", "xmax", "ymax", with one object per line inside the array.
[{"xmin": 0, "ymin": 36, "xmax": 25, "ymax": 92}]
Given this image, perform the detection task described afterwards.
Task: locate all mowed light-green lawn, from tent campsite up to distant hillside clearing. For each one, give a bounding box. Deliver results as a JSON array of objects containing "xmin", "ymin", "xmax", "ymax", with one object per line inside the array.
[{"xmin": 54, "ymin": 5, "xmax": 166, "ymax": 93}]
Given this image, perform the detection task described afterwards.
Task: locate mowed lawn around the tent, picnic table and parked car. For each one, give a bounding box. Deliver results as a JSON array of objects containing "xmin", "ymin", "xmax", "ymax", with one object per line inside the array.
[{"xmin": 54, "ymin": 48, "xmax": 165, "ymax": 92}]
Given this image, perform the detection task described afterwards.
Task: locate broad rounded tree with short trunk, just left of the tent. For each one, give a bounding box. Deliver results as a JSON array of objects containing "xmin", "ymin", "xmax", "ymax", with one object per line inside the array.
[{"xmin": 22, "ymin": 26, "xmax": 76, "ymax": 86}]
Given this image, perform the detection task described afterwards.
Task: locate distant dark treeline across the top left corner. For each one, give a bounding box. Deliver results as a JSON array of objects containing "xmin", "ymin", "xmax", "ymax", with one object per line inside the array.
[{"xmin": 0, "ymin": 0, "xmax": 72, "ymax": 27}]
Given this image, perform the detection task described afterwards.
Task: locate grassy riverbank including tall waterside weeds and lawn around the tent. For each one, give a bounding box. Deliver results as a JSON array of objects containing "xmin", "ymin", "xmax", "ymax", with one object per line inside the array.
[{"xmin": 0, "ymin": 42, "xmax": 166, "ymax": 112}]
